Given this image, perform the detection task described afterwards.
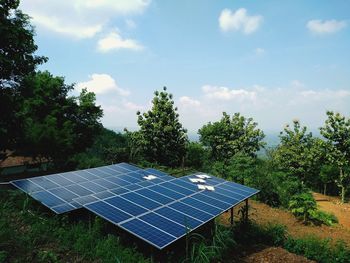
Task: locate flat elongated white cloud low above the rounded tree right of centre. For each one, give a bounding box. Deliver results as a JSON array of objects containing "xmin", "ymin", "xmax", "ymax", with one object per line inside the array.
[{"xmin": 202, "ymin": 85, "xmax": 257, "ymax": 101}]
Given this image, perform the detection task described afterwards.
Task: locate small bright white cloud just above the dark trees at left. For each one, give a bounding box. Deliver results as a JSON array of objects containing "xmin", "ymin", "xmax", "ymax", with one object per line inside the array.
[{"xmin": 76, "ymin": 73, "xmax": 130, "ymax": 96}]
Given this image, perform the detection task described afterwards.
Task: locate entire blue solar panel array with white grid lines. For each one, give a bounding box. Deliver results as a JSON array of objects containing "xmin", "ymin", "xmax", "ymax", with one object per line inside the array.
[{"xmin": 11, "ymin": 163, "xmax": 258, "ymax": 249}]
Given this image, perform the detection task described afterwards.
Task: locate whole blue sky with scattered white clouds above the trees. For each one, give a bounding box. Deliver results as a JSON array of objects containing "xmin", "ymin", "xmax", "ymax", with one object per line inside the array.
[{"xmin": 20, "ymin": 0, "xmax": 350, "ymax": 132}]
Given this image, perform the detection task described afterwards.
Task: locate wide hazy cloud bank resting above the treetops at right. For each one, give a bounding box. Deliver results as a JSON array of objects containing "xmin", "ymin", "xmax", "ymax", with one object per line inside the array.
[{"xmin": 179, "ymin": 84, "xmax": 350, "ymax": 134}]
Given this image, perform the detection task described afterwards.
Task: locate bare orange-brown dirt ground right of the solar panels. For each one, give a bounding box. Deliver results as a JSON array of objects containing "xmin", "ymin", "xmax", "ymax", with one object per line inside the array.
[{"xmin": 221, "ymin": 193, "xmax": 350, "ymax": 263}]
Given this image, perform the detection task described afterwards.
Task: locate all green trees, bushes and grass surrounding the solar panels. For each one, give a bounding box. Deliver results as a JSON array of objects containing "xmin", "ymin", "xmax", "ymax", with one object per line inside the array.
[{"xmin": 0, "ymin": 0, "xmax": 350, "ymax": 262}]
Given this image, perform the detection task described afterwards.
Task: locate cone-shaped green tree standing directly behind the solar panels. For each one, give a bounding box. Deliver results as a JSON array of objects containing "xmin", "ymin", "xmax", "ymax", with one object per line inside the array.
[{"xmin": 137, "ymin": 87, "xmax": 187, "ymax": 166}]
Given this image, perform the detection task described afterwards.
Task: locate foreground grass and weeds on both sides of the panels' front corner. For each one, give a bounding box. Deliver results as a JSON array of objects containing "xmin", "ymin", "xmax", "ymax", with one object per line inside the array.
[{"xmin": 0, "ymin": 190, "xmax": 350, "ymax": 263}]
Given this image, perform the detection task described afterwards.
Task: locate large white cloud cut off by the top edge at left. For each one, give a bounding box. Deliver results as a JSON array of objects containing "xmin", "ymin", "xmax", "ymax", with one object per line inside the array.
[{"xmin": 20, "ymin": 0, "xmax": 150, "ymax": 39}]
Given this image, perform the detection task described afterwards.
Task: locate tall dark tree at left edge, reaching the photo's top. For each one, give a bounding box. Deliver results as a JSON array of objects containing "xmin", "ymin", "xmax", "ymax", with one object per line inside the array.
[{"xmin": 0, "ymin": 0, "xmax": 47, "ymax": 156}]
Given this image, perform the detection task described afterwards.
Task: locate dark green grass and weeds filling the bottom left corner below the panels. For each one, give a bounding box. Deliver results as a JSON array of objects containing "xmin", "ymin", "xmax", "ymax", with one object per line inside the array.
[{"xmin": 0, "ymin": 190, "xmax": 151, "ymax": 262}]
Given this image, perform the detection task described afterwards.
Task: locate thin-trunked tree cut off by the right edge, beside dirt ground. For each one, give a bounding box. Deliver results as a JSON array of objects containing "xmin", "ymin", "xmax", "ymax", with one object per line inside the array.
[{"xmin": 320, "ymin": 111, "xmax": 350, "ymax": 203}]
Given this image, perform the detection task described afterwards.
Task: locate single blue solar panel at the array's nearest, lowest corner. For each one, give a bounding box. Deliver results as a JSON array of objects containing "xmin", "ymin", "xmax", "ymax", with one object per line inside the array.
[{"xmin": 121, "ymin": 219, "xmax": 176, "ymax": 249}]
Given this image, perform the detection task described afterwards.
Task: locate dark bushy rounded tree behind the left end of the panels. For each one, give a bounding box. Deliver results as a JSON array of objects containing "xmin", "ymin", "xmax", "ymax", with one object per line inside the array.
[{"xmin": 17, "ymin": 71, "xmax": 102, "ymax": 167}]
